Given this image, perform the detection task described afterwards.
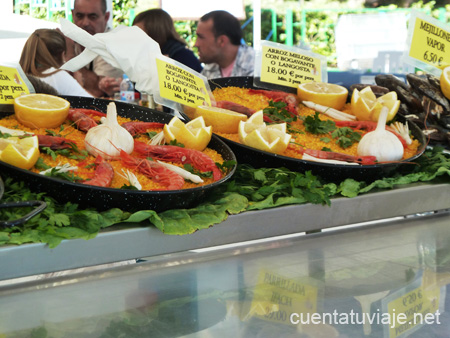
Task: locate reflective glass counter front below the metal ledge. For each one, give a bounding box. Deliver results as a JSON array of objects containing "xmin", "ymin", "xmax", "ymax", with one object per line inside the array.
[{"xmin": 0, "ymin": 207, "xmax": 450, "ymax": 338}]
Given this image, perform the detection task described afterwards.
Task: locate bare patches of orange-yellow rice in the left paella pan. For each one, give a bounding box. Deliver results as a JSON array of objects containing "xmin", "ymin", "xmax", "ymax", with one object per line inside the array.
[{"xmin": 0, "ymin": 115, "xmax": 223, "ymax": 190}]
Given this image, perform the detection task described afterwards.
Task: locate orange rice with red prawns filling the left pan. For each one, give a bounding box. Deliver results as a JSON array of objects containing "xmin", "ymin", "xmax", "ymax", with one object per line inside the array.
[{"xmin": 0, "ymin": 108, "xmax": 223, "ymax": 190}]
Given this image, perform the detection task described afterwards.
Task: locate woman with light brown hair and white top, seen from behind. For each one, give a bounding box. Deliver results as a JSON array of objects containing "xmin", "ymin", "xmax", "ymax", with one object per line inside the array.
[{"xmin": 19, "ymin": 29, "xmax": 92, "ymax": 97}]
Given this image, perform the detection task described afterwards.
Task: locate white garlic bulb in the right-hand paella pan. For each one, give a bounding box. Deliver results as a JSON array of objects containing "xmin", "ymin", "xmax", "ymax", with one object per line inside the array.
[{"xmin": 357, "ymin": 107, "xmax": 404, "ymax": 162}]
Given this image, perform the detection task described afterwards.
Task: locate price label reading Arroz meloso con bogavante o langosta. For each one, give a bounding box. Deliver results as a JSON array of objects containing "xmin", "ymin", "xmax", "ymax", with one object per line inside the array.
[{"xmin": 260, "ymin": 42, "xmax": 326, "ymax": 88}]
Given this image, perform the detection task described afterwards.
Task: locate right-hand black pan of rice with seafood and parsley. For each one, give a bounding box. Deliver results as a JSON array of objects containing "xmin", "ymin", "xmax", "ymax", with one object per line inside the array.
[{"xmin": 210, "ymin": 77, "xmax": 426, "ymax": 181}]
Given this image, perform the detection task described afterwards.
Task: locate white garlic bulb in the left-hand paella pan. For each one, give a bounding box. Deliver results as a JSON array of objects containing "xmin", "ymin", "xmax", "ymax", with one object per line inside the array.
[{"xmin": 84, "ymin": 102, "xmax": 134, "ymax": 160}]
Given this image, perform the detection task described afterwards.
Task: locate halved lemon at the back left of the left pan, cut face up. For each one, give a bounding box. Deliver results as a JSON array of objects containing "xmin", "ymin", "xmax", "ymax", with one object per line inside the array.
[{"xmin": 14, "ymin": 94, "xmax": 70, "ymax": 128}]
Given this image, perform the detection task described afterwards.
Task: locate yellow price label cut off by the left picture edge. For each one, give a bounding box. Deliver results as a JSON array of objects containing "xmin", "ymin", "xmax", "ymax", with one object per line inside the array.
[{"xmin": 0, "ymin": 66, "xmax": 30, "ymax": 104}]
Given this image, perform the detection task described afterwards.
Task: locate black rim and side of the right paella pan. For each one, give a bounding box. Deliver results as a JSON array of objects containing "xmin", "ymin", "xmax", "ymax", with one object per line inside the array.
[{"xmin": 209, "ymin": 77, "xmax": 426, "ymax": 182}]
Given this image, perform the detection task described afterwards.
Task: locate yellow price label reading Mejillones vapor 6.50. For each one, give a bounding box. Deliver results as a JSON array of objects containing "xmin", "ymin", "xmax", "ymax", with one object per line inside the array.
[{"xmin": 409, "ymin": 14, "xmax": 450, "ymax": 69}]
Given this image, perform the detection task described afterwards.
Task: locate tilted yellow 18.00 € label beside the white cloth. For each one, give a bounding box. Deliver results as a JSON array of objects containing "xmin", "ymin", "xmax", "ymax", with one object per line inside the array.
[{"xmin": 156, "ymin": 58, "xmax": 211, "ymax": 107}]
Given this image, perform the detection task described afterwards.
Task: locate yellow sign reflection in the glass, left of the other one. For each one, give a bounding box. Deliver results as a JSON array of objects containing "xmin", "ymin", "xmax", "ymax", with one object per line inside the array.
[{"xmin": 248, "ymin": 270, "xmax": 318, "ymax": 325}]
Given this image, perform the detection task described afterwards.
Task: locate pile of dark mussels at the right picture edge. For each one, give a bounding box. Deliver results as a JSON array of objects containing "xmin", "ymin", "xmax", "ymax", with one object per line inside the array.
[{"xmin": 353, "ymin": 74, "xmax": 450, "ymax": 147}]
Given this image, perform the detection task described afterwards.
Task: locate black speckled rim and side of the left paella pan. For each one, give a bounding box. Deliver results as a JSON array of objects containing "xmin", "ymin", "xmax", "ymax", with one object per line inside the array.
[{"xmin": 0, "ymin": 96, "xmax": 236, "ymax": 212}]
